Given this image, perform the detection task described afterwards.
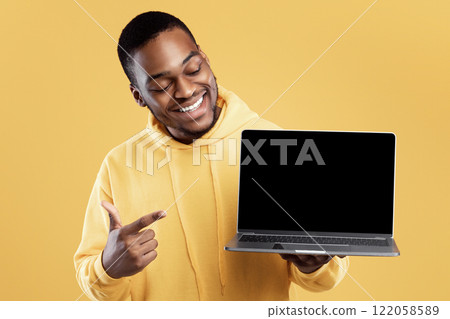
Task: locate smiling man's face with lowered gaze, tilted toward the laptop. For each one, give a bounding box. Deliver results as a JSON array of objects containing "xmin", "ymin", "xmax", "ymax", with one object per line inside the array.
[{"xmin": 130, "ymin": 28, "xmax": 220, "ymax": 144}]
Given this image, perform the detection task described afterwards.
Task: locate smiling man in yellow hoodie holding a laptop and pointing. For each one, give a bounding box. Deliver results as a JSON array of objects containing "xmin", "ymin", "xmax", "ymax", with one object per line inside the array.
[{"xmin": 74, "ymin": 12, "xmax": 348, "ymax": 300}]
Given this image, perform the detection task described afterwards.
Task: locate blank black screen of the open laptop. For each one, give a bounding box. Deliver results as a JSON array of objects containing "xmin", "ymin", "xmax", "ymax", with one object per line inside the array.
[{"xmin": 238, "ymin": 130, "xmax": 395, "ymax": 234}]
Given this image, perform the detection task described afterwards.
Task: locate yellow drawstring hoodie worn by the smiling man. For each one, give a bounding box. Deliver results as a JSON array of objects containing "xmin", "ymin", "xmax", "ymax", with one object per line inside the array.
[{"xmin": 74, "ymin": 85, "xmax": 348, "ymax": 300}]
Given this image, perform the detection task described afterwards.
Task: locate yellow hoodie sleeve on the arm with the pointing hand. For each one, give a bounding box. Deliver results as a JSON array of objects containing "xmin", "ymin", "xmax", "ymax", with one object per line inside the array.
[{"xmin": 74, "ymin": 157, "xmax": 131, "ymax": 300}]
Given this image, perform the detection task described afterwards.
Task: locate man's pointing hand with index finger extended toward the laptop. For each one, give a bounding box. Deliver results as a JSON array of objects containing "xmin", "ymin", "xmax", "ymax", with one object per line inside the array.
[{"xmin": 101, "ymin": 200, "xmax": 166, "ymax": 279}]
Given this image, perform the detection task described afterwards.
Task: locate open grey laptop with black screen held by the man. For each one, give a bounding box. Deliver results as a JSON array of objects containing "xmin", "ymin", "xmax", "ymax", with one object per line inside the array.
[{"xmin": 225, "ymin": 130, "xmax": 400, "ymax": 256}]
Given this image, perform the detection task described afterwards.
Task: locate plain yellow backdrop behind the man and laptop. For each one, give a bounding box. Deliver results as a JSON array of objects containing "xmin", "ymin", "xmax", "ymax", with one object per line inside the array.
[{"xmin": 0, "ymin": 0, "xmax": 450, "ymax": 300}]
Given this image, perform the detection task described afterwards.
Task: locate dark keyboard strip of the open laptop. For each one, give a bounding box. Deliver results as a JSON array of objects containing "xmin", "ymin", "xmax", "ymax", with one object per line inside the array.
[{"xmin": 239, "ymin": 235, "xmax": 388, "ymax": 246}]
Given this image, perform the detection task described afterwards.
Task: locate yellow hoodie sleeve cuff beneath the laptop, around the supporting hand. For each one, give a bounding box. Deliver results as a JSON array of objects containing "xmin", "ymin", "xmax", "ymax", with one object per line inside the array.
[{"xmin": 288, "ymin": 256, "xmax": 350, "ymax": 292}]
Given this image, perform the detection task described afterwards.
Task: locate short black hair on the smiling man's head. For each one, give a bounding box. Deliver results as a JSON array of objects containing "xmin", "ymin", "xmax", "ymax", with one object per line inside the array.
[{"xmin": 117, "ymin": 11, "xmax": 198, "ymax": 86}]
